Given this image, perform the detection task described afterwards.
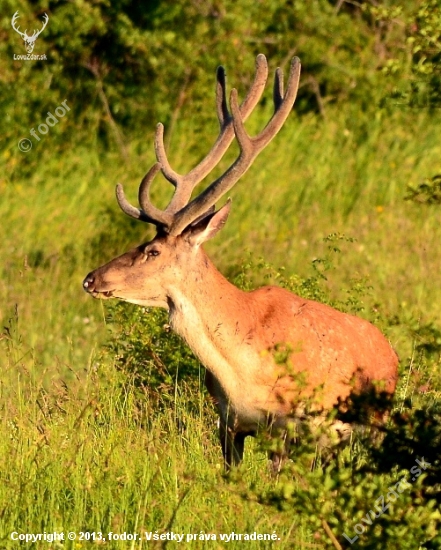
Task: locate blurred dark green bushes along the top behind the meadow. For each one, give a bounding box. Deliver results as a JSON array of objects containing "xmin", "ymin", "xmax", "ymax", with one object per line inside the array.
[{"xmin": 0, "ymin": 0, "xmax": 440, "ymax": 160}]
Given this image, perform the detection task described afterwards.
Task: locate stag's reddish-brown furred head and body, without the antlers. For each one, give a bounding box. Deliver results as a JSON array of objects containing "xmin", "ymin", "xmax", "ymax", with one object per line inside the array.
[{"xmin": 86, "ymin": 230, "xmax": 398, "ymax": 465}]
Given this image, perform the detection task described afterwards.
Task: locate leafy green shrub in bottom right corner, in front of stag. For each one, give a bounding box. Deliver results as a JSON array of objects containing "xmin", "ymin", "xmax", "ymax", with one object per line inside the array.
[{"xmin": 248, "ymin": 398, "xmax": 441, "ymax": 550}]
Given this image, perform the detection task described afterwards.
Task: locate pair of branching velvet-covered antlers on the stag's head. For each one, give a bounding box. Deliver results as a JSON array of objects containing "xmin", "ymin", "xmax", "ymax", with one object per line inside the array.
[{"xmin": 116, "ymin": 54, "xmax": 300, "ymax": 235}]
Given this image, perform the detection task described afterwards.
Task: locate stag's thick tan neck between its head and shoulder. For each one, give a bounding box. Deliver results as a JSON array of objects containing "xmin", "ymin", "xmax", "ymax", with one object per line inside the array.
[{"xmin": 169, "ymin": 250, "xmax": 256, "ymax": 402}]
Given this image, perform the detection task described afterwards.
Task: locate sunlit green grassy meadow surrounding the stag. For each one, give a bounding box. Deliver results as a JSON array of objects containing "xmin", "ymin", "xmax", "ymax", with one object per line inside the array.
[{"xmin": 0, "ymin": 92, "xmax": 441, "ymax": 549}]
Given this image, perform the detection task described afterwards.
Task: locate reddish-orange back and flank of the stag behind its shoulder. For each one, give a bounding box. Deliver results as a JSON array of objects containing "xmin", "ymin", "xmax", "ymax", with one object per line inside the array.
[{"xmin": 250, "ymin": 287, "xmax": 398, "ymax": 408}]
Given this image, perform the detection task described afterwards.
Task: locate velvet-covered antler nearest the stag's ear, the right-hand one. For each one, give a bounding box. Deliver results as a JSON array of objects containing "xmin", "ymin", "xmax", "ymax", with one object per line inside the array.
[{"xmin": 169, "ymin": 57, "xmax": 300, "ymax": 235}]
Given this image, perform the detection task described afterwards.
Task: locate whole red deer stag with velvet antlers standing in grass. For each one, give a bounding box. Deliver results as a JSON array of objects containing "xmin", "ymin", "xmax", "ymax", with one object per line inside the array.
[{"xmin": 83, "ymin": 55, "xmax": 398, "ymax": 468}]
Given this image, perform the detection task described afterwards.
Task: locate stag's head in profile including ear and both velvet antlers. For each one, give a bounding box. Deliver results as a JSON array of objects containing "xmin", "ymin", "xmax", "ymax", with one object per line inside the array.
[{"xmin": 83, "ymin": 55, "xmax": 300, "ymax": 307}]
